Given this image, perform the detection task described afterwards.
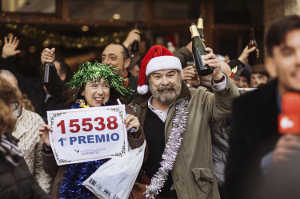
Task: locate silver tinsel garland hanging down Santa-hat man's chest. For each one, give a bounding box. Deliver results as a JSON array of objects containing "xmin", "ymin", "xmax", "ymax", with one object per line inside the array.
[{"xmin": 145, "ymin": 100, "xmax": 188, "ymax": 199}]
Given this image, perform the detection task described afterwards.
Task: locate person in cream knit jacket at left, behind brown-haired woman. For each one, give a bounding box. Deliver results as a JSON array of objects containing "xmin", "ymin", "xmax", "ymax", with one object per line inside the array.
[{"xmin": 0, "ymin": 75, "xmax": 52, "ymax": 193}]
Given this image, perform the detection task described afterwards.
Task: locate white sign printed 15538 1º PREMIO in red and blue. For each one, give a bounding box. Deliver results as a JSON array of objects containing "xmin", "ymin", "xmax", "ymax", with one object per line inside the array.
[{"xmin": 47, "ymin": 105, "xmax": 128, "ymax": 165}]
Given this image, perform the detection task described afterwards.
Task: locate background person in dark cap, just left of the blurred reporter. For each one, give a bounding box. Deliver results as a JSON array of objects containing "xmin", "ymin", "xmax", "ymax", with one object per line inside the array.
[{"xmin": 250, "ymin": 64, "xmax": 269, "ymax": 88}]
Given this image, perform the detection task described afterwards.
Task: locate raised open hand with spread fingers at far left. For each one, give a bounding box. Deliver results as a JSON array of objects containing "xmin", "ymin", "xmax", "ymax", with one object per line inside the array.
[{"xmin": 2, "ymin": 34, "xmax": 21, "ymax": 59}]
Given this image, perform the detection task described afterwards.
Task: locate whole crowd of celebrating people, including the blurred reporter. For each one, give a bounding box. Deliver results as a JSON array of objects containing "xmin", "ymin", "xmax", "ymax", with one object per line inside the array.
[{"xmin": 0, "ymin": 15, "xmax": 300, "ymax": 199}]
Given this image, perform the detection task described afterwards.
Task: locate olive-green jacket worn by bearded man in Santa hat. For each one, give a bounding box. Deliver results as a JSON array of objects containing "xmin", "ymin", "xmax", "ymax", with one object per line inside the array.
[{"xmin": 134, "ymin": 78, "xmax": 239, "ymax": 199}]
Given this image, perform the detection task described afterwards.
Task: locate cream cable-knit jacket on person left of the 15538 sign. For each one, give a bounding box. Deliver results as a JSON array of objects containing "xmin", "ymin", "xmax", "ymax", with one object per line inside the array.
[{"xmin": 12, "ymin": 108, "xmax": 51, "ymax": 193}]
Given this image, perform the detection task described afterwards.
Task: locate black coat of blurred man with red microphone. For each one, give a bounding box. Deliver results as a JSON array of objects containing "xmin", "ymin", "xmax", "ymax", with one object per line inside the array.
[{"xmin": 225, "ymin": 80, "xmax": 279, "ymax": 199}]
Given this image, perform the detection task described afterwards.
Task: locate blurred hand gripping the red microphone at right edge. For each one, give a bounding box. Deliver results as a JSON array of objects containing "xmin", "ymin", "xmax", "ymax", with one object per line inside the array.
[{"xmin": 272, "ymin": 134, "xmax": 300, "ymax": 164}]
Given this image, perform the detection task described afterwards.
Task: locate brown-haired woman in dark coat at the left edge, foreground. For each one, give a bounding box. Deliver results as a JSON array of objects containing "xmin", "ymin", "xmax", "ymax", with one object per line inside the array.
[{"xmin": 0, "ymin": 77, "xmax": 49, "ymax": 199}]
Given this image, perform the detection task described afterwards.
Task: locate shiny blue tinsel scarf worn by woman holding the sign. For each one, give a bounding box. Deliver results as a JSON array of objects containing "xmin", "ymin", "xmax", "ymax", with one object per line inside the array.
[{"xmin": 59, "ymin": 99, "xmax": 109, "ymax": 199}]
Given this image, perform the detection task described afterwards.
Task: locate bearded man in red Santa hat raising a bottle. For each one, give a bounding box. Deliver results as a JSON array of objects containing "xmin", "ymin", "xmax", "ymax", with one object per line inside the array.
[{"xmin": 131, "ymin": 45, "xmax": 238, "ymax": 199}]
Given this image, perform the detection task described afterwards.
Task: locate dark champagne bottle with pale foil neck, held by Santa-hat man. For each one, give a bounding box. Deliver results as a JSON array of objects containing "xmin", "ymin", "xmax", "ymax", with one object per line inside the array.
[{"xmin": 190, "ymin": 24, "xmax": 213, "ymax": 76}]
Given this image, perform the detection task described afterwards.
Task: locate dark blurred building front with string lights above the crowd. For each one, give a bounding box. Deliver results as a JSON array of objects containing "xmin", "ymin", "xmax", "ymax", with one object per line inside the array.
[{"xmin": 0, "ymin": 0, "xmax": 299, "ymax": 76}]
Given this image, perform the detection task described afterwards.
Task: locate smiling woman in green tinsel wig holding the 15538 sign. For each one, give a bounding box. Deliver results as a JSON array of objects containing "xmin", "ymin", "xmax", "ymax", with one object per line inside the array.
[{"xmin": 40, "ymin": 62, "xmax": 144, "ymax": 199}]
